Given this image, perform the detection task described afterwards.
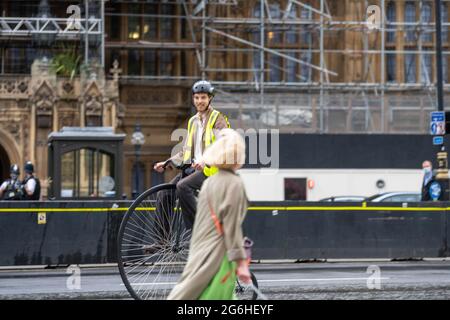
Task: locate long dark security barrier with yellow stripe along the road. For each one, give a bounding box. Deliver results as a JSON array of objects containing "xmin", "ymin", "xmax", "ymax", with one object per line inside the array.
[{"xmin": 0, "ymin": 201, "xmax": 450, "ymax": 266}]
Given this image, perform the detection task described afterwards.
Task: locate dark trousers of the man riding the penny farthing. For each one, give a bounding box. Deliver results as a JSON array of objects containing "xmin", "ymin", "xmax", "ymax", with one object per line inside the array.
[{"xmin": 156, "ymin": 171, "xmax": 207, "ymax": 238}]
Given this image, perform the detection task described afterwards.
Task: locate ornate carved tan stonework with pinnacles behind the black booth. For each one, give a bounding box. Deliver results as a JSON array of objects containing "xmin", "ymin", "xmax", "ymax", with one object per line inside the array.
[{"xmin": 0, "ymin": 57, "xmax": 121, "ymax": 185}]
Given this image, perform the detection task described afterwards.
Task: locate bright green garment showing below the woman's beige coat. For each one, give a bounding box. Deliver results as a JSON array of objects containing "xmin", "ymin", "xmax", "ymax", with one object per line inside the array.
[{"xmin": 198, "ymin": 254, "xmax": 237, "ymax": 300}]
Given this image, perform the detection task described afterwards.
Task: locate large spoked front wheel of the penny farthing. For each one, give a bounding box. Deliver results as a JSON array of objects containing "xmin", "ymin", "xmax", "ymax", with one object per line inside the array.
[{"xmin": 118, "ymin": 184, "xmax": 190, "ymax": 300}]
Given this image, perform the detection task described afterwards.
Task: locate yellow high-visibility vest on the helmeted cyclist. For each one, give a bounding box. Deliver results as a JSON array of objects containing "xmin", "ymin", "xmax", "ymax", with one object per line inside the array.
[{"xmin": 183, "ymin": 110, "xmax": 231, "ymax": 177}]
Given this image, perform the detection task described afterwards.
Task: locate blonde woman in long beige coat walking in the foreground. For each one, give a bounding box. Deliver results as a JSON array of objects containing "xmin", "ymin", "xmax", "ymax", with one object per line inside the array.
[{"xmin": 168, "ymin": 129, "xmax": 251, "ymax": 300}]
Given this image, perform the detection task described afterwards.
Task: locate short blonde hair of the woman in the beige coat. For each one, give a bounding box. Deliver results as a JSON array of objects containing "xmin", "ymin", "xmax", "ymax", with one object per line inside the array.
[{"xmin": 203, "ymin": 129, "xmax": 245, "ymax": 169}]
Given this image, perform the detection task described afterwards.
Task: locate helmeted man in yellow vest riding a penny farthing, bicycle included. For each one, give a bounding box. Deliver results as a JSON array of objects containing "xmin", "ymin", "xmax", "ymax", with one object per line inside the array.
[{"xmin": 118, "ymin": 80, "xmax": 230, "ymax": 299}]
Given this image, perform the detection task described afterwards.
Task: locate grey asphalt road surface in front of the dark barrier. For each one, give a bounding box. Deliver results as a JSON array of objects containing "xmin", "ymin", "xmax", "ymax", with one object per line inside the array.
[{"xmin": 0, "ymin": 259, "xmax": 450, "ymax": 300}]
